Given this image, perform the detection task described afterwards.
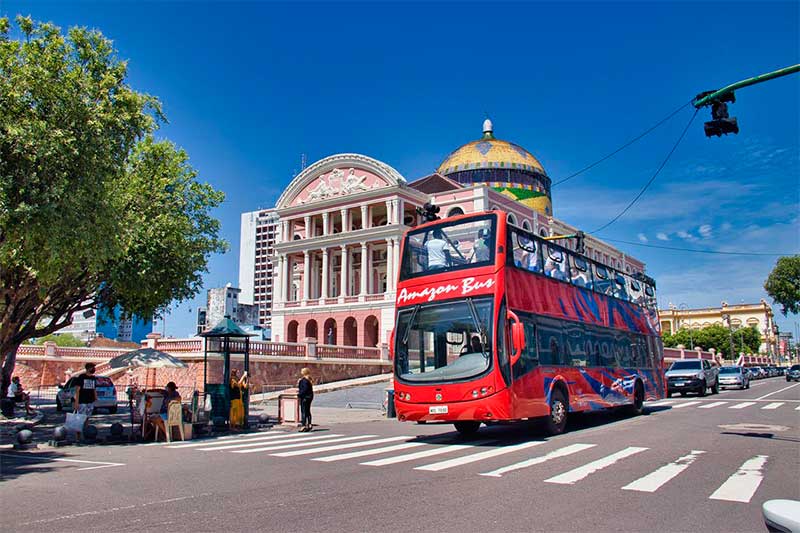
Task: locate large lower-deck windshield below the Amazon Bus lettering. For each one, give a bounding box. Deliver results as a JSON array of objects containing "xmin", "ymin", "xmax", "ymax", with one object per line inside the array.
[{"xmin": 395, "ymin": 297, "xmax": 492, "ymax": 382}]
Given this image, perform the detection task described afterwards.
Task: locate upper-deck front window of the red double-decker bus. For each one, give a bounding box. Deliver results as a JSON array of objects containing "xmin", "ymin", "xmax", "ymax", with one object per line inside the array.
[{"xmin": 400, "ymin": 215, "xmax": 496, "ymax": 280}]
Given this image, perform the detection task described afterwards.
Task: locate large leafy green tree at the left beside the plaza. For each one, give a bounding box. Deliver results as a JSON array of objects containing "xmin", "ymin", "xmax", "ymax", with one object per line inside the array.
[{"xmin": 0, "ymin": 17, "xmax": 227, "ymax": 394}]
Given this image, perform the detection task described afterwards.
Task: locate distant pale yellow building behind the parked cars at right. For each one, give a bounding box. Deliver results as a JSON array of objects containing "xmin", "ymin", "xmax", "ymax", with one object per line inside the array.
[{"xmin": 658, "ymin": 300, "xmax": 778, "ymax": 354}]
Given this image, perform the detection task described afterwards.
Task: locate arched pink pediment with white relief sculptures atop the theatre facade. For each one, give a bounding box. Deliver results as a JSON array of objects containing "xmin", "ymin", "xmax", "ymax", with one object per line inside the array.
[{"xmin": 276, "ymin": 154, "xmax": 405, "ymax": 209}]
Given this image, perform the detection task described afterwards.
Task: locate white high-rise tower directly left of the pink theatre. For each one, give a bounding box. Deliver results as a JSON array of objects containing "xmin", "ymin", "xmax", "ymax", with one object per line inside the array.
[{"xmin": 239, "ymin": 209, "xmax": 278, "ymax": 328}]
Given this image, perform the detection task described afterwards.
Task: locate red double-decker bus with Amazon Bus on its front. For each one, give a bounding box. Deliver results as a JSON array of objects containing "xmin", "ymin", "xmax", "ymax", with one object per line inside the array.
[{"xmin": 391, "ymin": 211, "xmax": 665, "ymax": 434}]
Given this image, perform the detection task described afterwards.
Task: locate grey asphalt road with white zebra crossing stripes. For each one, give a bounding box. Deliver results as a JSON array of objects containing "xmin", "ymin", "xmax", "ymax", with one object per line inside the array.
[{"xmin": 0, "ymin": 378, "xmax": 800, "ymax": 532}]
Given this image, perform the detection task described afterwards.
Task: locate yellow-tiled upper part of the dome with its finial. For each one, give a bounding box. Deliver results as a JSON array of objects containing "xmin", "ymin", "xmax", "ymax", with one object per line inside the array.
[{"xmin": 437, "ymin": 119, "xmax": 547, "ymax": 176}]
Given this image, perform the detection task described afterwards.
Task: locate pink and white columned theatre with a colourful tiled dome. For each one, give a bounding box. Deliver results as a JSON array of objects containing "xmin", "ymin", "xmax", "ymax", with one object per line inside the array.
[{"xmin": 244, "ymin": 120, "xmax": 644, "ymax": 347}]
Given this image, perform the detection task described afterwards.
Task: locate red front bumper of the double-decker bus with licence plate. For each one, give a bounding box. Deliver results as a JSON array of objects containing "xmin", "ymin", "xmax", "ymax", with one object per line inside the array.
[{"xmin": 395, "ymin": 389, "xmax": 513, "ymax": 423}]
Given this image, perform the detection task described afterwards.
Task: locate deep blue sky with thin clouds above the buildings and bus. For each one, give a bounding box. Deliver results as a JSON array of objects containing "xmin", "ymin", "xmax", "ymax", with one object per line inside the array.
[{"xmin": 6, "ymin": 0, "xmax": 800, "ymax": 336}]
